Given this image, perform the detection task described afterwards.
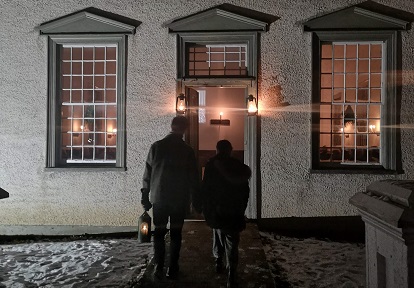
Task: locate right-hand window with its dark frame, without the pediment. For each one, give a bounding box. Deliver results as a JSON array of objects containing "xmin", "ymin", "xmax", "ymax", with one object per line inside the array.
[{"xmin": 312, "ymin": 31, "xmax": 397, "ymax": 172}]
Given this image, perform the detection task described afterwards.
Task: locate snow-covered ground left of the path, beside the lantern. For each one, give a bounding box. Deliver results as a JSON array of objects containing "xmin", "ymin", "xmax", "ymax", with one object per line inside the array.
[{"xmin": 0, "ymin": 239, "xmax": 152, "ymax": 288}]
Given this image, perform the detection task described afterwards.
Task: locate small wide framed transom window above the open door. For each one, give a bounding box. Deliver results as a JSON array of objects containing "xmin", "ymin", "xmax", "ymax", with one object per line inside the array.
[{"xmin": 177, "ymin": 32, "xmax": 257, "ymax": 79}]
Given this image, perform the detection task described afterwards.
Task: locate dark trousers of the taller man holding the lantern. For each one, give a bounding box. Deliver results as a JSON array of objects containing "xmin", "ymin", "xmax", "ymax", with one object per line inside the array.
[{"xmin": 152, "ymin": 203, "xmax": 185, "ymax": 269}]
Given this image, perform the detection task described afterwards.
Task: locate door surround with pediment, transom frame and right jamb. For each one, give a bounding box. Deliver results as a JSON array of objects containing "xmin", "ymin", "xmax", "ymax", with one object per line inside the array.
[{"xmin": 165, "ymin": 3, "xmax": 279, "ymax": 219}]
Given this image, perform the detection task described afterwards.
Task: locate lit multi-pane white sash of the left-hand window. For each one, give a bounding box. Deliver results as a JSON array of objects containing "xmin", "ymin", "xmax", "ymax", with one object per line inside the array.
[{"xmin": 60, "ymin": 44, "xmax": 118, "ymax": 163}]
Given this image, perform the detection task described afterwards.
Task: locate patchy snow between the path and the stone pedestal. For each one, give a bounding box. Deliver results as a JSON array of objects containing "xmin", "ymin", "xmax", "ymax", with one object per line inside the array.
[{"xmin": 260, "ymin": 232, "xmax": 365, "ymax": 288}]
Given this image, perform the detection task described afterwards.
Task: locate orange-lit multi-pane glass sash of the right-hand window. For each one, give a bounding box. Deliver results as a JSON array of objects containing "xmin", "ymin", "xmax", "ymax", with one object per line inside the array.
[{"xmin": 319, "ymin": 42, "xmax": 386, "ymax": 165}]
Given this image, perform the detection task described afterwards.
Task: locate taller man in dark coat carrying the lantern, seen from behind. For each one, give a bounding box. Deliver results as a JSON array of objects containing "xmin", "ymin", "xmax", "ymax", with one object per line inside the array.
[{"xmin": 141, "ymin": 116, "xmax": 201, "ymax": 279}]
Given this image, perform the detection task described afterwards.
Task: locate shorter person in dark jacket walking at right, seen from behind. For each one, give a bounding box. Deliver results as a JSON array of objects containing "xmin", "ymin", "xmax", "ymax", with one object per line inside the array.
[{"xmin": 201, "ymin": 140, "xmax": 251, "ymax": 287}]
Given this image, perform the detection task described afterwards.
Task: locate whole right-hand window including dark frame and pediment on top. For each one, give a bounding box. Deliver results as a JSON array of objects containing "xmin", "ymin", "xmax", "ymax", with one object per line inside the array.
[{"xmin": 303, "ymin": 3, "xmax": 410, "ymax": 174}]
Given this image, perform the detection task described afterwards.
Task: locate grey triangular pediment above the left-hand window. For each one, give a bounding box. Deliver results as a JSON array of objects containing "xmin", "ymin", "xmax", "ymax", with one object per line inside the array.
[{"xmin": 37, "ymin": 11, "xmax": 141, "ymax": 35}]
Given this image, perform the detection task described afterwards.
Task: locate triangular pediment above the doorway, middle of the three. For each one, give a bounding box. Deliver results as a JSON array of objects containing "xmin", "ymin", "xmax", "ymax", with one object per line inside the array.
[{"xmin": 166, "ymin": 4, "xmax": 278, "ymax": 33}]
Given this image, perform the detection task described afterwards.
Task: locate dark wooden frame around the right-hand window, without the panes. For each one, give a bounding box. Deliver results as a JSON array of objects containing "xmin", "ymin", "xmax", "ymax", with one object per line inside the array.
[{"xmin": 311, "ymin": 31, "xmax": 399, "ymax": 173}]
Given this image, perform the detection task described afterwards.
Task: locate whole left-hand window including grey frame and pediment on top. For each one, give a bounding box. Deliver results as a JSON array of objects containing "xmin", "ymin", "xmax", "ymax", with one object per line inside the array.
[{"xmin": 38, "ymin": 7, "xmax": 136, "ymax": 169}]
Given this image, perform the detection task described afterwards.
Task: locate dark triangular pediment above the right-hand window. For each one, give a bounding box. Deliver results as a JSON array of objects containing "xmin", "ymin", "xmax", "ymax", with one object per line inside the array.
[{"xmin": 303, "ymin": 6, "xmax": 410, "ymax": 31}]
